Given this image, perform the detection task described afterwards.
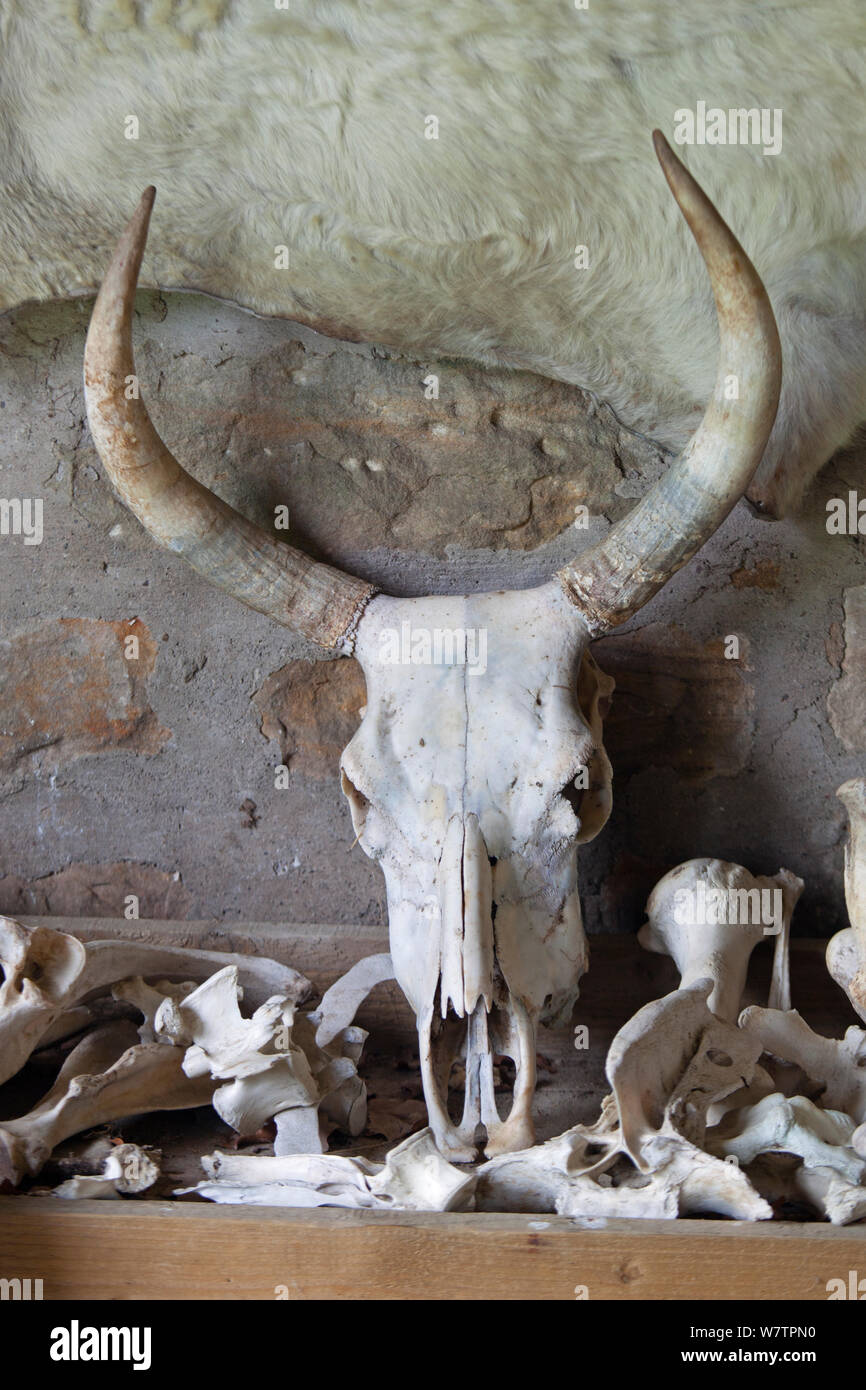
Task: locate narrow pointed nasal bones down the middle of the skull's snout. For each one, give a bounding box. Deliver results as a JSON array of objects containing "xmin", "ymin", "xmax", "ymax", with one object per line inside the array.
[{"xmin": 439, "ymin": 812, "xmax": 493, "ymax": 1017}]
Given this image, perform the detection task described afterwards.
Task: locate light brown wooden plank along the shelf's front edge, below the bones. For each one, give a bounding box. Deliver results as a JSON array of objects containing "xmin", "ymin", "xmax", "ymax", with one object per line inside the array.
[{"xmin": 0, "ymin": 1197, "xmax": 866, "ymax": 1301}]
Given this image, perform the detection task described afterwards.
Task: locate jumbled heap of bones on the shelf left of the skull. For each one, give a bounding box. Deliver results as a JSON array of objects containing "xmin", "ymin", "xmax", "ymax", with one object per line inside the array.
[{"xmin": 0, "ymin": 917, "xmax": 380, "ymax": 1193}]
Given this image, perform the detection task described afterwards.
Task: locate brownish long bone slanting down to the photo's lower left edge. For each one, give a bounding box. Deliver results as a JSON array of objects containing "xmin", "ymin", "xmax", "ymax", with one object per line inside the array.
[{"xmin": 0, "ymin": 1022, "xmax": 213, "ymax": 1183}]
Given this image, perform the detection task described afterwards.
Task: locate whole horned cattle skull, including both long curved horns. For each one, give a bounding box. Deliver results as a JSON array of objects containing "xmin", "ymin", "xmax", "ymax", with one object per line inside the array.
[{"xmin": 85, "ymin": 132, "xmax": 781, "ymax": 1158}]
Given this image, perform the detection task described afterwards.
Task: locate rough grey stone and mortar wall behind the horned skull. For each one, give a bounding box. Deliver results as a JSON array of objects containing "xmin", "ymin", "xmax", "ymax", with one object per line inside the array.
[{"xmin": 0, "ymin": 293, "xmax": 866, "ymax": 934}]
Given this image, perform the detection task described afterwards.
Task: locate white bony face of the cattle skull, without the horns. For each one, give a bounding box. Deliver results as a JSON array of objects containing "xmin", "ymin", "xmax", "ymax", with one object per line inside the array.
[{"xmin": 342, "ymin": 585, "xmax": 613, "ymax": 1159}]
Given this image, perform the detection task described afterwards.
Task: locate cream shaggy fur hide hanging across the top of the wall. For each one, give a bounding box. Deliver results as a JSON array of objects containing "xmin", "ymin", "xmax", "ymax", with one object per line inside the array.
[{"xmin": 0, "ymin": 0, "xmax": 866, "ymax": 512}]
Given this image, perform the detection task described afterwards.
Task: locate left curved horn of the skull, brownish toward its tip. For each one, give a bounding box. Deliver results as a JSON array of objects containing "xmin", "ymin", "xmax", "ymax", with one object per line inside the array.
[{"xmin": 85, "ymin": 188, "xmax": 377, "ymax": 652}]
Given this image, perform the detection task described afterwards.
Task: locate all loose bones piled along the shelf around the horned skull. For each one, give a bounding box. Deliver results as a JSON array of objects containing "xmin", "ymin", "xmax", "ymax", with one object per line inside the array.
[{"xmin": 0, "ymin": 780, "xmax": 866, "ymax": 1223}]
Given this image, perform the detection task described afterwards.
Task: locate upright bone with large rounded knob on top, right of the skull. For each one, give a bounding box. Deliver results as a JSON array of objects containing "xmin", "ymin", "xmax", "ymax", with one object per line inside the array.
[{"xmin": 638, "ymin": 859, "xmax": 803, "ymax": 1022}]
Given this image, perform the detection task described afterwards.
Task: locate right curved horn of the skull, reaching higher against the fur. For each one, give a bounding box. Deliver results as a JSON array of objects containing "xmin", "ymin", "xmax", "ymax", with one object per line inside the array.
[{"xmin": 559, "ymin": 131, "xmax": 781, "ymax": 635}]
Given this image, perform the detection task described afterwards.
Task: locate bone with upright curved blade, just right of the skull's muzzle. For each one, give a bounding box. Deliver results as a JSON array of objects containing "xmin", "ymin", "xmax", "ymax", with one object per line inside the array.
[{"xmin": 477, "ymin": 980, "xmax": 771, "ymax": 1220}]
